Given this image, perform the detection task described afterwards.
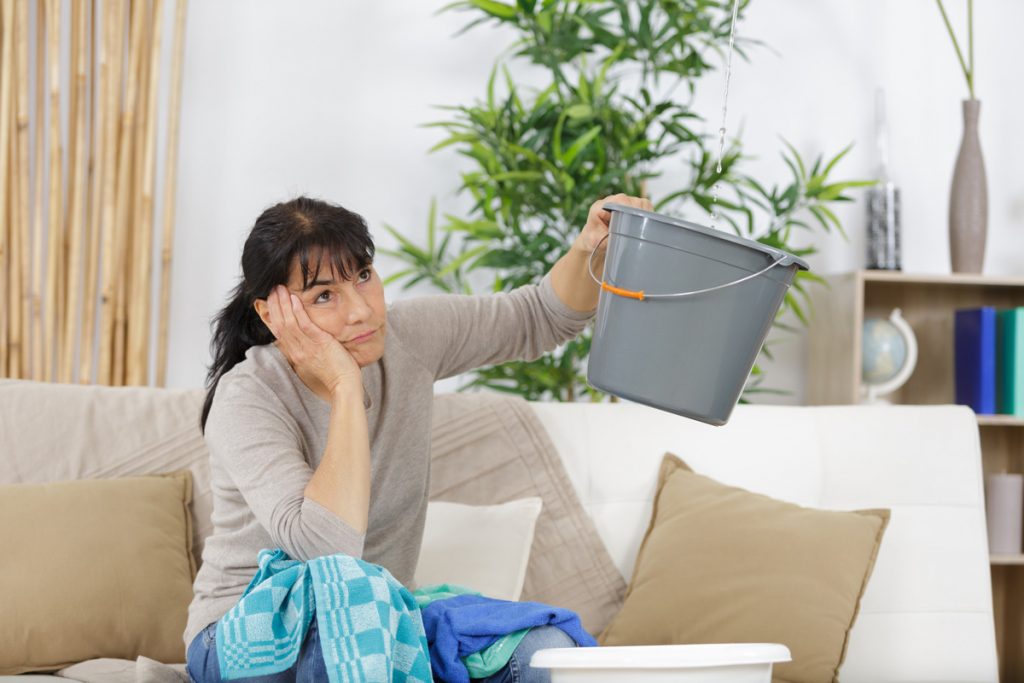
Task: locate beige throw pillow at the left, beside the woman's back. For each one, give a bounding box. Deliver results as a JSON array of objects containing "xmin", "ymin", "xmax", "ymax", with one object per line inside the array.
[{"xmin": 0, "ymin": 470, "xmax": 196, "ymax": 675}]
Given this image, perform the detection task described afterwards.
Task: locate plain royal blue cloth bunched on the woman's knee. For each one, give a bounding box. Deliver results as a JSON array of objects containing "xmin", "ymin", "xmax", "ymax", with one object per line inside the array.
[{"xmin": 423, "ymin": 595, "xmax": 597, "ymax": 683}]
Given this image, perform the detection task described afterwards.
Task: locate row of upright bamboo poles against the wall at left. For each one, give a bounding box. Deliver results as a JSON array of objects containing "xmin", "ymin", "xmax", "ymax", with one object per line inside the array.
[{"xmin": 0, "ymin": 0, "xmax": 185, "ymax": 384}]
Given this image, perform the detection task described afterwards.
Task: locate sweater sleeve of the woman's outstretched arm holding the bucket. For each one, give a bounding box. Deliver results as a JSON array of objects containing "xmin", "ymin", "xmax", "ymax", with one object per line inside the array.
[{"xmin": 389, "ymin": 273, "xmax": 594, "ymax": 379}]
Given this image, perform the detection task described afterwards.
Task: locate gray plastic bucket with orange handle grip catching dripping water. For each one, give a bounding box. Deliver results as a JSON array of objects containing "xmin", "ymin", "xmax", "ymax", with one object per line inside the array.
[{"xmin": 587, "ymin": 204, "xmax": 809, "ymax": 425}]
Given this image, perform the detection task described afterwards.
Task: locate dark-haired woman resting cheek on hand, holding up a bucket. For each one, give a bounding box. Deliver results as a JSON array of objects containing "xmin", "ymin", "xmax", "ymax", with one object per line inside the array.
[{"xmin": 184, "ymin": 195, "xmax": 650, "ymax": 683}]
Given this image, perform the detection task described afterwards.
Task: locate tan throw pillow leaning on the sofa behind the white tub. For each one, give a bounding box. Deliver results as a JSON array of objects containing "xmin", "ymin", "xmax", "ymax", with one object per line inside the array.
[{"xmin": 600, "ymin": 454, "xmax": 889, "ymax": 683}]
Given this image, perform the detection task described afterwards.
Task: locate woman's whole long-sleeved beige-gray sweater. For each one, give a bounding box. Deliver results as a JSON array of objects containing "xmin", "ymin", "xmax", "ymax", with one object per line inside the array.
[{"xmin": 184, "ymin": 274, "xmax": 593, "ymax": 647}]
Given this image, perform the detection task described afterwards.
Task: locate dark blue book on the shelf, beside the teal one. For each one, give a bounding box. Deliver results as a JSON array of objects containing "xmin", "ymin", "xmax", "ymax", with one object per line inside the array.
[{"xmin": 953, "ymin": 306, "xmax": 996, "ymax": 415}]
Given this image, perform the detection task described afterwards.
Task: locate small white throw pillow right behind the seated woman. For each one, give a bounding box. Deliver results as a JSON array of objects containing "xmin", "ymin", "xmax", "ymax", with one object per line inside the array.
[{"xmin": 415, "ymin": 498, "xmax": 541, "ymax": 600}]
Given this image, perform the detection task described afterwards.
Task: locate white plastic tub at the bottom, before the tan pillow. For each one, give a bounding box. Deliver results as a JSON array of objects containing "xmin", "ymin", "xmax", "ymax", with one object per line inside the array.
[{"xmin": 529, "ymin": 643, "xmax": 792, "ymax": 683}]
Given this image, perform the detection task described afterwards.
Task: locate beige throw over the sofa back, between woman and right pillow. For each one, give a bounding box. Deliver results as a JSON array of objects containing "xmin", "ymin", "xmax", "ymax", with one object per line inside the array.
[{"xmin": 430, "ymin": 393, "xmax": 626, "ymax": 633}]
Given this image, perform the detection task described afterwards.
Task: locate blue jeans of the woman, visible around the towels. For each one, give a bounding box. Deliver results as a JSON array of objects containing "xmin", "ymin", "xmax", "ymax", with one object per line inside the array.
[{"xmin": 186, "ymin": 618, "xmax": 575, "ymax": 683}]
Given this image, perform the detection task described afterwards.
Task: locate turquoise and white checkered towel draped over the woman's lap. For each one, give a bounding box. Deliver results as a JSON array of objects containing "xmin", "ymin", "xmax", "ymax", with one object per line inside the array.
[{"xmin": 217, "ymin": 549, "xmax": 432, "ymax": 683}]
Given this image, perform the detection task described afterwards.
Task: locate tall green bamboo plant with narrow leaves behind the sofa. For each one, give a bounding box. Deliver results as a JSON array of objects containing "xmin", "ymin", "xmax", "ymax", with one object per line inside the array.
[{"xmin": 385, "ymin": 0, "xmax": 870, "ymax": 400}]
